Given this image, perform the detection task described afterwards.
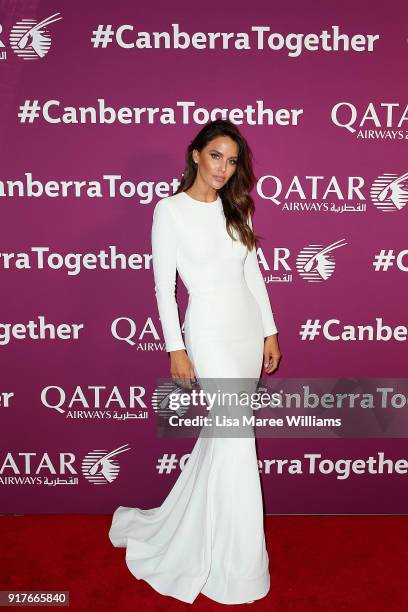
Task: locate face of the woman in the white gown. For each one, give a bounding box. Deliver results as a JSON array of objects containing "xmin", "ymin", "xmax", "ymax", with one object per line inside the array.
[{"xmin": 193, "ymin": 136, "xmax": 238, "ymax": 189}]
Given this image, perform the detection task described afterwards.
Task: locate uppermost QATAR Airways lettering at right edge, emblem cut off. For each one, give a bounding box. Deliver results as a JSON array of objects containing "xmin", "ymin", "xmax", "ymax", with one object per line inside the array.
[{"xmin": 331, "ymin": 102, "xmax": 408, "ymax": 140}]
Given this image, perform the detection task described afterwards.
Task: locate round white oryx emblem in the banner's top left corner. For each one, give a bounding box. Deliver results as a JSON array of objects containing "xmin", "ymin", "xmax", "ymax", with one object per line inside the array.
[{"xmin": 10, "ymin": 13, "xmax": 62, "ymax": 60}]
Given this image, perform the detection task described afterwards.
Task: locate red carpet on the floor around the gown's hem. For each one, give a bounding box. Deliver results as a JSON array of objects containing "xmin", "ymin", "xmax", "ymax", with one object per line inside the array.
[{"xmin": 0, "ymin": 515, "xmax": 408, "ymax": 612}]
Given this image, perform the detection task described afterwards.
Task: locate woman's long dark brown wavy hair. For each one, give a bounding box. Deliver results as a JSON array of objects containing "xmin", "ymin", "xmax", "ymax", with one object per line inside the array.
[{"xmin": 175, "ymin": 119, "xmax": 258, "ymax": 250}]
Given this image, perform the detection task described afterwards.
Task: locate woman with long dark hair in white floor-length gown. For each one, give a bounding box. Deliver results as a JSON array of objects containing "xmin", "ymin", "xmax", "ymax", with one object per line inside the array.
[{"xmin": 109, "ymin": 120, "xmax": 281, "ymax": 604}]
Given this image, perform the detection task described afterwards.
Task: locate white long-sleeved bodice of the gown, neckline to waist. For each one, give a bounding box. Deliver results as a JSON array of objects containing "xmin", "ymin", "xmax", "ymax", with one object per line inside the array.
[{"xmin": 152, "ymin": 192, "xmax": 277, "ymax": 351}]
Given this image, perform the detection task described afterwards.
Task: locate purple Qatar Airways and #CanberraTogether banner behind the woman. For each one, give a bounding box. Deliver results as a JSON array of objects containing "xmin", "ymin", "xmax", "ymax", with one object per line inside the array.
[{"xmin": 0, "ymin": 0, "xmax": 408, "ymax": 514}]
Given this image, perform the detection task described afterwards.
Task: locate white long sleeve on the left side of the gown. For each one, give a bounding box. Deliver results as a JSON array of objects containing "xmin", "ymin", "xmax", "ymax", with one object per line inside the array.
[{"xmin": 151, "ymin": 198, "xmax": 185, "ymax": 352}]
